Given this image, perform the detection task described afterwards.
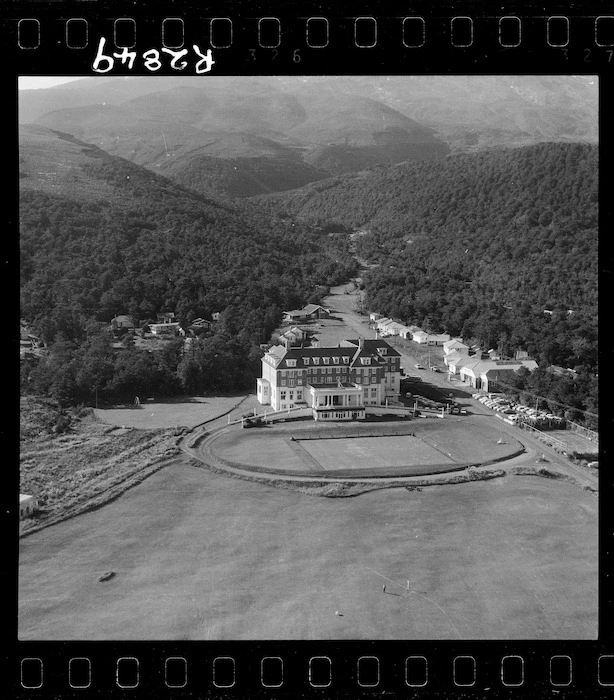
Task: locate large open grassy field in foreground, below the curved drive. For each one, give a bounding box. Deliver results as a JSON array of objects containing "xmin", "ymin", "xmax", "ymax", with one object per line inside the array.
[{"xmin": 19, "ymin": 463, "xmax": 598, "ymax": 640}]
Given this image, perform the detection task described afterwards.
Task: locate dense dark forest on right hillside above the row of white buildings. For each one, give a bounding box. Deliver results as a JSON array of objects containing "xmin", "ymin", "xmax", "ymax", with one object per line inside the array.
[{"xmin": 258, "ymin": 143, "xmax": 598, "ymax": 426}]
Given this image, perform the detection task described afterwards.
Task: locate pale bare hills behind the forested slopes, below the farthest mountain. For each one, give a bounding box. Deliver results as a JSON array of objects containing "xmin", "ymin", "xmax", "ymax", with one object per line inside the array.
[{"xmin": 20, "ymin": 78, "xmax": 449, "ymax": 196}]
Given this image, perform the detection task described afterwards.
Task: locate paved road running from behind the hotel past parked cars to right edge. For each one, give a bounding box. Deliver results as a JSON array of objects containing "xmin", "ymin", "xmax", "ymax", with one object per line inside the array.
[{"xmin": 322, "ymin": 283, "xmax": 599, "ymax": 489}]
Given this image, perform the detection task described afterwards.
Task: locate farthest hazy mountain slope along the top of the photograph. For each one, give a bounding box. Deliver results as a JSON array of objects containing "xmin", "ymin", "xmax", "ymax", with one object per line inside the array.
[{"xmin": 19, "ymin": 75, "xmax": 598, "ymax": 150}]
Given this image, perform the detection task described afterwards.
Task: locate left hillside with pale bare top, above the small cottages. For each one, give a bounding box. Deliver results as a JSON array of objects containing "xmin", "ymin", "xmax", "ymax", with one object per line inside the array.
[{"xmin": 20, "ymin": 125, "xmax": 355, "ymax": 345}]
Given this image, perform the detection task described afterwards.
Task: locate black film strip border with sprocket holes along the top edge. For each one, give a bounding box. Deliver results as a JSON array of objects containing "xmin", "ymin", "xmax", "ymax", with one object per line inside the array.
[{"xmin": 3, "ymin": 6, "xmax": 614, "ymax": 74}]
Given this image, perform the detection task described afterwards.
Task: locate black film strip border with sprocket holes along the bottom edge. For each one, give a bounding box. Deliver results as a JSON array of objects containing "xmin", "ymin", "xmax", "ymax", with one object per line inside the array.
[{"xmin": 11, "ymin": 645, "xmax": 614, "ymax": 697}]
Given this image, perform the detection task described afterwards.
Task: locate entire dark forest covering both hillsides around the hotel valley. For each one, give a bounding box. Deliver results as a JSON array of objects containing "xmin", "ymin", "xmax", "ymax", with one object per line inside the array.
[{"xmin": 20, "ymin": 128, "xmax": 598, "ymax": 430}]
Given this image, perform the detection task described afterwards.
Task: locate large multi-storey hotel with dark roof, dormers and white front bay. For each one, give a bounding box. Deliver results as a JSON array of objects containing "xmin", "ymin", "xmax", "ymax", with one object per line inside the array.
[{"xmin": 257, "ymin": 338, "xmax": 401, "ymax": 420}]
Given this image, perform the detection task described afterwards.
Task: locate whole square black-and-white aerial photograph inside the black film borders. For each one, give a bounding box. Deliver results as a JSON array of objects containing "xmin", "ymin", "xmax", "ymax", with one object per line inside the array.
[{"xmin": 18, "ymin": 74, "xmax": 600, "ymax": 642}]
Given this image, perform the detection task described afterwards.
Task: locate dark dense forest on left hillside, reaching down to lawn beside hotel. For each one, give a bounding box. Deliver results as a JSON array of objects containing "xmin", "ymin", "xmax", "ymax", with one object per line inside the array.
[{"xmin": 20, "ymin": 139, "xmax": 357, "ymax": 403}]
